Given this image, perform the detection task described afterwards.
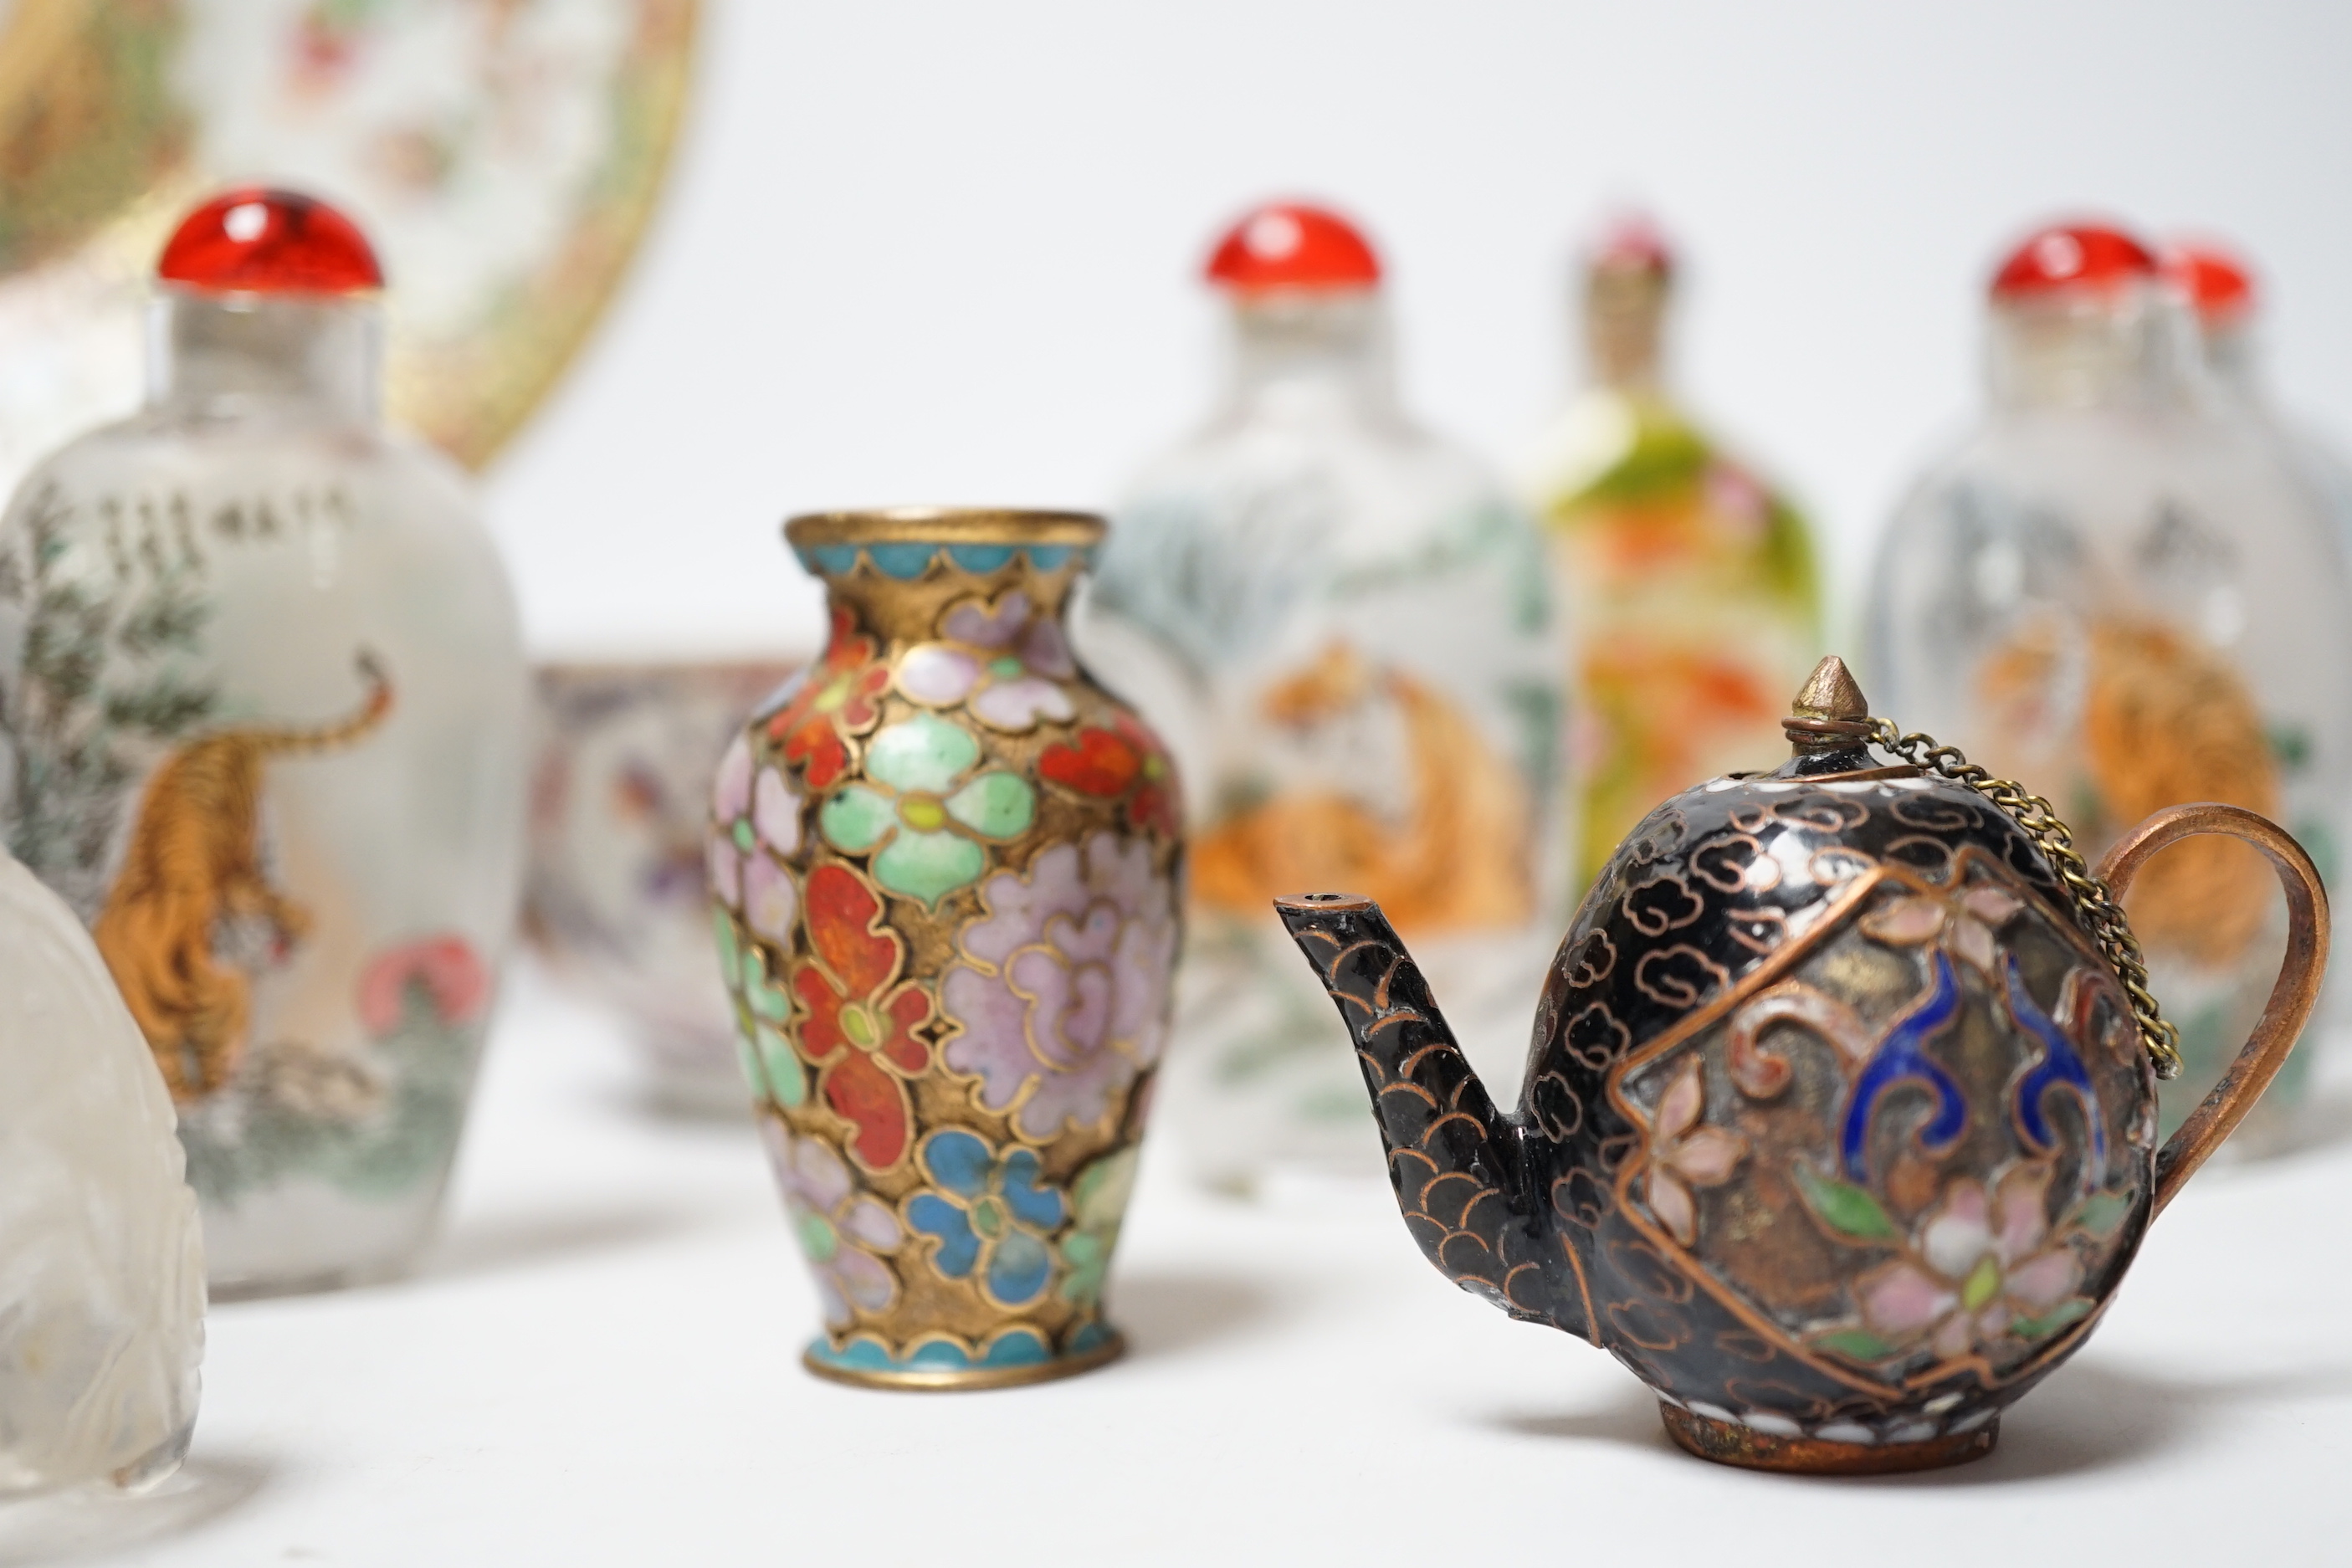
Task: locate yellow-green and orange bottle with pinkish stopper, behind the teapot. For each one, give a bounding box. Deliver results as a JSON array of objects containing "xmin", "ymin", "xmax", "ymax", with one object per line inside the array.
[{"xmin": 1524, "ymin": 218, "xmax": 1821, "ymax": 889}]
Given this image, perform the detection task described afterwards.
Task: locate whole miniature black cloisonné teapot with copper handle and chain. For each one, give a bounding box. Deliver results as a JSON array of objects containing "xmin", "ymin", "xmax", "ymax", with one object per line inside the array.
[{"xmin": 1277, "ymin": 658, "xmax": 2329, "ymax": 1472}]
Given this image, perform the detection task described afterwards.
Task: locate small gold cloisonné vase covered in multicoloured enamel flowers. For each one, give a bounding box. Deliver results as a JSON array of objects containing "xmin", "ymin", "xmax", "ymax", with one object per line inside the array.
[{"xmin": 710, "ymin": 508, "xmax": 1181, "ymax": 1389}]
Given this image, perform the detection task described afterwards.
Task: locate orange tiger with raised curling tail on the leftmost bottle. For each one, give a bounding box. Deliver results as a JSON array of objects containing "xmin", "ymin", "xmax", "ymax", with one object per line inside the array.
[{"xmin": 92, "ymin": 651, "xmax": 392, "ymax": 1103}]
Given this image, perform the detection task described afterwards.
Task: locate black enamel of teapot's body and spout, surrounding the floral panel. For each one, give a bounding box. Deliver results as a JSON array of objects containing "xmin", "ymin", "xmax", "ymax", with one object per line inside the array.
[{"xmin": 1282, "ymin": 752, "xmax": 2143, "ymax": 1429}]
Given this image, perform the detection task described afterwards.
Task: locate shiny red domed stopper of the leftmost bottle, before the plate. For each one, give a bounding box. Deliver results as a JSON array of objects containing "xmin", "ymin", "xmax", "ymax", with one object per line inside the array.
[{"xmin": 156, "ymin": 186, "xmax": 383, "ymax": 294}]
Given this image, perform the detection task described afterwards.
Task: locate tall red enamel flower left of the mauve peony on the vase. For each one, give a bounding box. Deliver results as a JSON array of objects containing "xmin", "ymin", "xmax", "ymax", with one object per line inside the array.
[{"xmin": 792, "ymin": 865, "xmax": 931, "ymax": 1171}]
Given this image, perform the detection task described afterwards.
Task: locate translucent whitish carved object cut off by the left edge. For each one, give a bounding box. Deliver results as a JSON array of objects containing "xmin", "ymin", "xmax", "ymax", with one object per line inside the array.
[{"xmin": 0, "ymin": 851, "xmax": 205, "ymax": 1498}]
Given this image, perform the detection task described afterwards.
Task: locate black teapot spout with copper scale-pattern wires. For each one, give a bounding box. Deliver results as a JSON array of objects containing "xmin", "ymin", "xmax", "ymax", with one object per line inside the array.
[{"xmin": 1275, "ymin": 894, "xmax": 1590, "ymax": 1335}]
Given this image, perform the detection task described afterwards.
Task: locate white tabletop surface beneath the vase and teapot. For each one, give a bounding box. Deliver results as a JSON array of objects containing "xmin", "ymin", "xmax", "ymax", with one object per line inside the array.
[{"xmin": 13, "ymin": 973, "xmax": 2352, "ymax": 1568}]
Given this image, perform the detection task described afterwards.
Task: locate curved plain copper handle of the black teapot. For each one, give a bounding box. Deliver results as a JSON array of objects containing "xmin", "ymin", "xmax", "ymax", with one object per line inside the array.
[{"xmin": 2098, "ymin": 802, "xmax": 2329, "ymax": 1217}]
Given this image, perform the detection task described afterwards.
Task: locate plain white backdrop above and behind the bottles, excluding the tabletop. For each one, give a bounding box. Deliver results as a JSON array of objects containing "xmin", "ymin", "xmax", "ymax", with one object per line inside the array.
[{"xmin": 489, "ymin": 0, "xmax": 2352, "ymax": 651}]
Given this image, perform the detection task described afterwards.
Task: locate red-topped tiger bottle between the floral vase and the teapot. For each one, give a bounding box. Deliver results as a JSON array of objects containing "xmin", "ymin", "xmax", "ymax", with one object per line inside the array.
[{"xmin": 1075, "ymin": 204, "xmax": 1566, "ymax": 1191}]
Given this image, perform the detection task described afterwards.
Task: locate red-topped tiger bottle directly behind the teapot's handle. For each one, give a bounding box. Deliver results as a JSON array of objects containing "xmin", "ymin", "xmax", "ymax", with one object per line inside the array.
[{"xmin": 1865, "ymin": 226, "xmax": 2352, "ymax": 1150}]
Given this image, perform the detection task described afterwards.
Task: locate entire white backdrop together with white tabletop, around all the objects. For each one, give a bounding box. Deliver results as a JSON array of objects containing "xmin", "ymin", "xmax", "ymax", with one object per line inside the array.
[{"xmin": 23, "ymin": 0, "xmax": 2352, "ymax": 1568}]
